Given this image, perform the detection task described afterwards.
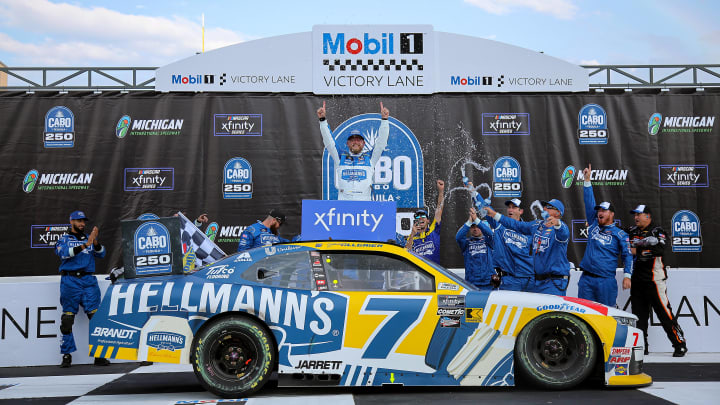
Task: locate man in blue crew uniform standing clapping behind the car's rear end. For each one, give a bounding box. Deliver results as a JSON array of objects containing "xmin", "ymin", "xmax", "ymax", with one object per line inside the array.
[{"xmin": 55, "ymin": 211, "xmax": 110, "ymax": 367}]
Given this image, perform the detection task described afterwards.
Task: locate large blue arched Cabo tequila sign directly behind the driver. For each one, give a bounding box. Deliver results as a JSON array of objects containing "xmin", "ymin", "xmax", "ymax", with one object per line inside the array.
[{"xmin": 315, "ymin": 113, "xmax": 425, "ymax": 208}]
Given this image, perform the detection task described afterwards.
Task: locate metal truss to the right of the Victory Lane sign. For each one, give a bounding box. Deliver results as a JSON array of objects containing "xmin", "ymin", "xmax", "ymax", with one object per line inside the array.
[{"xmin": 582, "ymin": 65, "xmax": 720, "ymax": 89}]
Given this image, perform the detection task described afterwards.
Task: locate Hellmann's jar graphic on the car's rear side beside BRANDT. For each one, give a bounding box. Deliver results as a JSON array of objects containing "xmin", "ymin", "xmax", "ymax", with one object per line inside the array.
[{"xmin": 138, "ymin": 315, "xmax": 193, "ymax": 363}]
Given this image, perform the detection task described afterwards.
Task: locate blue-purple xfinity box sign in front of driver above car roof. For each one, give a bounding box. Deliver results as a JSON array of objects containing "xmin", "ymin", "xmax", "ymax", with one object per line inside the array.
[{"xmin": 302, "ymin": 200, "xmax": 396, "ymax": 242}]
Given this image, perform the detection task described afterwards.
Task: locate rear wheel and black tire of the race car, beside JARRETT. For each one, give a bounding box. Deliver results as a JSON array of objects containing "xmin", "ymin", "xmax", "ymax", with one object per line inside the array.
[{"xmin": 190, "ymin": 316, "xmax": 276, "ymax": 398}]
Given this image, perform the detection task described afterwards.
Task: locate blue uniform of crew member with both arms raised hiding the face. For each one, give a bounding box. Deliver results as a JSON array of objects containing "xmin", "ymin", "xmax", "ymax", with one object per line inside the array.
[{"xmin": 455, "ymin": 218, "xmax": 495, "ymax": 290}]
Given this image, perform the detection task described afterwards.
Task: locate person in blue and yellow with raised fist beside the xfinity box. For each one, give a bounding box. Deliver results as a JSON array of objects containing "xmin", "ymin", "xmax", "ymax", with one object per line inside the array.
[{"xmin": 405, "ymin": 180, "xmax": 445, "ymax": 263}]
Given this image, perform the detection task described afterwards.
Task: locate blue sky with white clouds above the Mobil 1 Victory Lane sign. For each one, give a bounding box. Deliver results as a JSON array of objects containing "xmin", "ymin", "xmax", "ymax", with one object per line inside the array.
[{"xmin": 0, "ymin": 0, "xmax": 720, "ymax": 66}]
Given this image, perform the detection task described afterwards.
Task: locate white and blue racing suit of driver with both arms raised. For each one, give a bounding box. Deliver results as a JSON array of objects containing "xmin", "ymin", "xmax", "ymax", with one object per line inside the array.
[{"xmin": 320, "ymin": 120, "xmax": 390, "ymax": 201}]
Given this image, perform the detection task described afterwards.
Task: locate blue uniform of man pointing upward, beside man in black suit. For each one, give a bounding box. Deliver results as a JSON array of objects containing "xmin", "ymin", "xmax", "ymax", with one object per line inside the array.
[{"xmin": 578, "ymin": 182, "xmax": 633, "ymax": 307}]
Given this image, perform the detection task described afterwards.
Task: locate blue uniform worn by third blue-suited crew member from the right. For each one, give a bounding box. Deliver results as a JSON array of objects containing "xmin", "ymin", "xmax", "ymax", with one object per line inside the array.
[{"xmin": 487, "ymin": 217, "xmax": 535, "ymax": 292}]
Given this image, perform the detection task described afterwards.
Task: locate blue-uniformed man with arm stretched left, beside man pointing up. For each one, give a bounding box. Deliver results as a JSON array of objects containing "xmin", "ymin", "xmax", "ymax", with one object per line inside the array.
[{"xmin": 487, "ymin": 199, "xmax": 570, "ymax": 295}]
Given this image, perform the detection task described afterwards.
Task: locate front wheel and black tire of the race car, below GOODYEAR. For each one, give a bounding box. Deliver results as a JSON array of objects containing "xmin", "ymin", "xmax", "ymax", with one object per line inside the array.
[{"xmin": 515, "ymin": 312, "xmax": 597, "ymax": 389}]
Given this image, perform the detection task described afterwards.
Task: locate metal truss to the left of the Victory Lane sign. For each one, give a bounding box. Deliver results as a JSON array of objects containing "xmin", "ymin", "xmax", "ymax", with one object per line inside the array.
[{"xmin": 0, "ymin": 66, "xmax": 157, "ymax": 92}]
